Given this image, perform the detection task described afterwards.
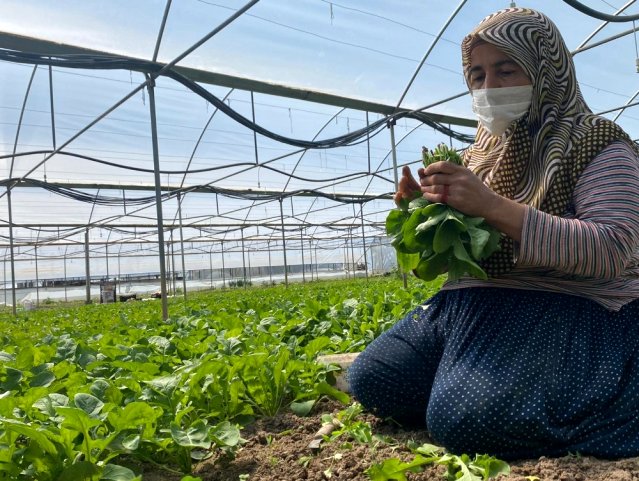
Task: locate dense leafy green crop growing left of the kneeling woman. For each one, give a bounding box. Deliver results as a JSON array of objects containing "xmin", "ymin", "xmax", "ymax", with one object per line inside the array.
[{"xmin": 0, "ymin": 278, "xmax": 438, "ymax": 481}]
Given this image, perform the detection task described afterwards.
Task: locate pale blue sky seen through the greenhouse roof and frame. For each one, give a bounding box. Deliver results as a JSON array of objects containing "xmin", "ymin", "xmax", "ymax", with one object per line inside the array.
[{"xmin": 0, "ymin": 0, "xmax": 639, "ymax": 282}]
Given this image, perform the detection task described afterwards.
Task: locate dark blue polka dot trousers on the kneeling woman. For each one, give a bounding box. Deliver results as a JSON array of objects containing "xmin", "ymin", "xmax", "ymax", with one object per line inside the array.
[{"xmin": 348, "ymin": 287, "xmax": 639, "ymax": 459}]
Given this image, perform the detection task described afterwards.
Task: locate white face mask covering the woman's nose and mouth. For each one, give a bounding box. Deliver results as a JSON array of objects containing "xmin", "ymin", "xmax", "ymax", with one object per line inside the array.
[{"xmin": 471, "ymin": 85, "xmax": 532, "ymax": 135}]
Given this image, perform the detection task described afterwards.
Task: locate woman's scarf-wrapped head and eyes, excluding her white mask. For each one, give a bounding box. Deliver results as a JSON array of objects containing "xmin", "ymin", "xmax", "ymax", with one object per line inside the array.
[{"xmin": 462, "ymin": 8, "xmax": 589, "ymax": 132}]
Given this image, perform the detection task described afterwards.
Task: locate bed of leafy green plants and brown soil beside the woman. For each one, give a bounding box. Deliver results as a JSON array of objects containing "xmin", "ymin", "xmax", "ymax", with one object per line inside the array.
[{"xmin": 0, "ymin": 278, "xmax": 639, "ymax": 481}]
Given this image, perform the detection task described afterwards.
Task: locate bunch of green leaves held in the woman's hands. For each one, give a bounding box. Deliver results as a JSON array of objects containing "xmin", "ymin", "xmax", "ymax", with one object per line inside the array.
[{"xmin": 386, "ymin": 144, "xmax": 501, "ymax": 281}]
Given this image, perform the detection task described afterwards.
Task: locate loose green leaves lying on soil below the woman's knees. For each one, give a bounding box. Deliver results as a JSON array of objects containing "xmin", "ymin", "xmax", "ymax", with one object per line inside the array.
[{"xmin": 366, "ymin": 444, "xmax": 510, "ymax": 481}]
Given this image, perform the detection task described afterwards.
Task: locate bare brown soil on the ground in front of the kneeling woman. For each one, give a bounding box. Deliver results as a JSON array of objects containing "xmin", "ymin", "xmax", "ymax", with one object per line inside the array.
[{"xmin": 142, "ymin": 401, "xmax": 639, "ymax": 481}]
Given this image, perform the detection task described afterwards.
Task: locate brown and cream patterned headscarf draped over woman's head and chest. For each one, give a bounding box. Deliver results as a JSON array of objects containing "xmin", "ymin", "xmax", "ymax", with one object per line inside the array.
[{"xmin": 462, "ymin": 8, "xmax": 629, "ymax": 276}]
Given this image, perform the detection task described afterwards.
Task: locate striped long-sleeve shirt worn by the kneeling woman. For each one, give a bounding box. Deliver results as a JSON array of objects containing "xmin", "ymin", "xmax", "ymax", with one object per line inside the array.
[{"xmin": 443, "ymin": 142, "xmax": 639, "ymax": 310}]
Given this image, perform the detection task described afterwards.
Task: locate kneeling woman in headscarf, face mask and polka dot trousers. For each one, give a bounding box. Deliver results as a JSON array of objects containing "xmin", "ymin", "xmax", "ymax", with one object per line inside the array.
[{"xmin": 349, "ymin": 8, "xmax": 639, "ymax": 459}]
